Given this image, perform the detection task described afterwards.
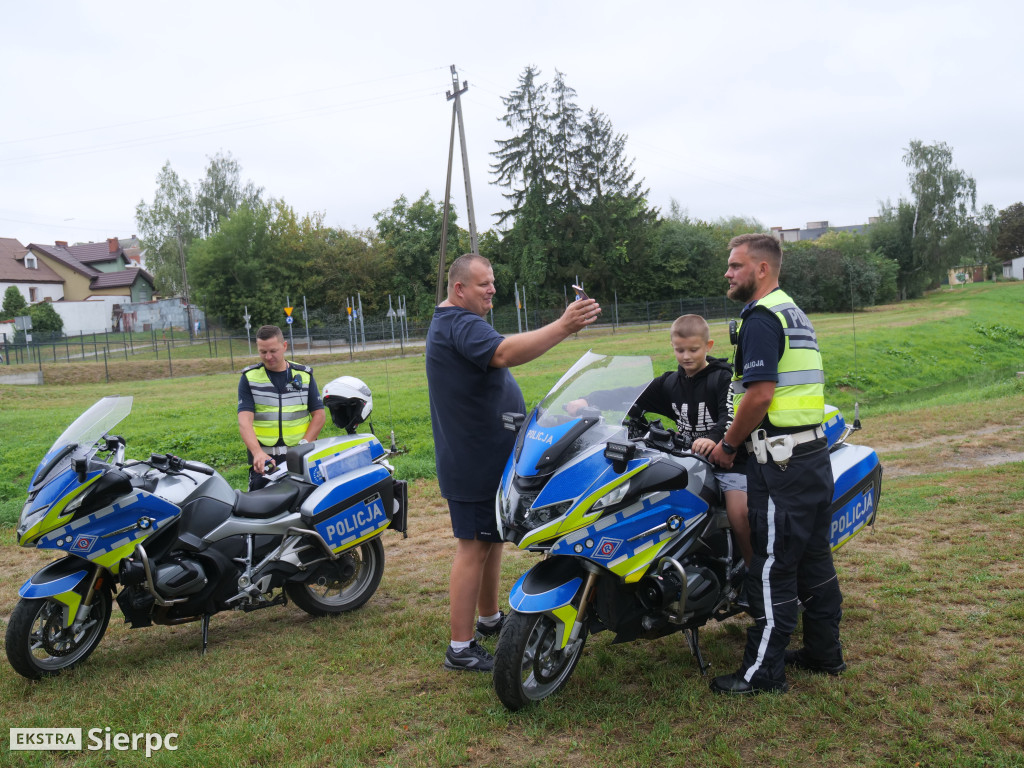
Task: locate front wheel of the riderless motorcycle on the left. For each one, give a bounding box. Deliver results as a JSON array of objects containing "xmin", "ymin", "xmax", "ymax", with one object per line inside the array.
[{"xmin": 6, "ymin": 589, "xmax": 113, "ymax": 680}]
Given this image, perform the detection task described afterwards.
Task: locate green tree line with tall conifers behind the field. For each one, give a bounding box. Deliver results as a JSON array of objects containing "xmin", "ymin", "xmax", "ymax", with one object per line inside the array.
[{"xmin": 136, "ymin": 67, "xmax": 1024, "ymax": 329}]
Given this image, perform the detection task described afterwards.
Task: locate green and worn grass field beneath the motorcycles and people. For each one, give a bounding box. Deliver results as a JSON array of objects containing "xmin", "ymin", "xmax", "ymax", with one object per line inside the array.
[{"xmin": 0, "ymin": 284, "xmax": 1024, "ymax": 768}]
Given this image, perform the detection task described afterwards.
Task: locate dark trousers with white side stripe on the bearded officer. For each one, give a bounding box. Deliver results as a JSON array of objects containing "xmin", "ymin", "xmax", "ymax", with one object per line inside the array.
[{"xmin": 738, "ymin": 438, "xmax": 843, "ymax": 683}]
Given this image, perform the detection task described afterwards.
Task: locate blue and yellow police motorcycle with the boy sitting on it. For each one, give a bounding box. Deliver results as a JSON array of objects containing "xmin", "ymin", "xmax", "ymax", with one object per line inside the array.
[{"xmin": 494, "ymin": 352, "xmax": 882, "ymax": 711}]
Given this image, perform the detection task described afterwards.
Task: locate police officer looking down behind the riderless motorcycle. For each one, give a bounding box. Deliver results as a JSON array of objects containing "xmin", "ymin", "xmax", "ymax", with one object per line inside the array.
[{"xmin": 239, "ymin": 326, "xmax": 327, "ymax": 490}]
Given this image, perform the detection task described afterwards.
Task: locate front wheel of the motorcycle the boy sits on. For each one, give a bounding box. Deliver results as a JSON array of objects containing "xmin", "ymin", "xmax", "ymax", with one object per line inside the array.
[{"xmin": 493, "ymin": 611, "xmax": 587, "ymax": 712}]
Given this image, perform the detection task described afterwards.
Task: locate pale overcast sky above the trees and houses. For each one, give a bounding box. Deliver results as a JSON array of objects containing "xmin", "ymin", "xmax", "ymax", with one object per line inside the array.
[{"xmin": 0, "ymin": 0, "xmax": 1024, "ymax": 244}]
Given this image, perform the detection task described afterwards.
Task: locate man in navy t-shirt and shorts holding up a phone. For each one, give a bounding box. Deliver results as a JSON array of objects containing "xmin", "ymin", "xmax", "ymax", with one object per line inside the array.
[{"xmin": 427, "ymin": 253, "xmax": 601, "ymax": 672}]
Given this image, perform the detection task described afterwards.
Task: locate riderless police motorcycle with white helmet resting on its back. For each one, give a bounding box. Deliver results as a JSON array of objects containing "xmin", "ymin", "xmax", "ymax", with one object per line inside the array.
[{"xmin": 6, "ymin": 377, "xmax": 408, "ymax": 679}]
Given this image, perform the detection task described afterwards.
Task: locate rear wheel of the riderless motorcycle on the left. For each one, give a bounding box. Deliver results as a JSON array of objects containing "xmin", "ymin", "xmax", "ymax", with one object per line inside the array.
[{"xmin": 285, "ymin": 537, "xmax": 384, "ymax": 616}]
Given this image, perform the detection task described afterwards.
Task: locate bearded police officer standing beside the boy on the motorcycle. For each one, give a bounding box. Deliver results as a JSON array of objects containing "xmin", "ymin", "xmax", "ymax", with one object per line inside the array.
[{"xmin": 711, "ymin": 234, "xmax": 846, "ymax": 694}]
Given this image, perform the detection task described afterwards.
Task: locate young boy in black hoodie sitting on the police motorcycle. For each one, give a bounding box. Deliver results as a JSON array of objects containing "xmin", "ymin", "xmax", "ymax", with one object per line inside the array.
[{"xmin": 566, "ymin": 314, "xmax": 754, "ymax": 567}]
